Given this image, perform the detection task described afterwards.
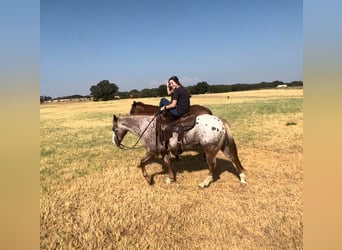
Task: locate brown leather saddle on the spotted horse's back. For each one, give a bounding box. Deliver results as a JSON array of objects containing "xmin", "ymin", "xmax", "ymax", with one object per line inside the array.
[{"xmin": 156, "ymin": 111, "xmax": 196, "ymax": 154}]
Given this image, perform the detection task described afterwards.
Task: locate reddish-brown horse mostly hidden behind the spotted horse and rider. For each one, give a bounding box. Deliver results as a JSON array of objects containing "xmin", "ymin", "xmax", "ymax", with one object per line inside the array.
[{"xmin": 130, "ymin": 101, "xmax": 213, "ymax": 115}]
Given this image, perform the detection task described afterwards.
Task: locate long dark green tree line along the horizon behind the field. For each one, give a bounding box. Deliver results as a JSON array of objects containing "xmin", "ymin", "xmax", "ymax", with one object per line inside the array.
[{"xmin": 40, "ymin": 80, "xmax": 303, "ymax": 103}]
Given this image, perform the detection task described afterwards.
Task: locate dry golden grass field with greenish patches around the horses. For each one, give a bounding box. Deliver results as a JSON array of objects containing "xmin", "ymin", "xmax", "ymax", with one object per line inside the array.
[{"xmin": 40, "ymin": 89, "xmax": 303, "ymax": 249}]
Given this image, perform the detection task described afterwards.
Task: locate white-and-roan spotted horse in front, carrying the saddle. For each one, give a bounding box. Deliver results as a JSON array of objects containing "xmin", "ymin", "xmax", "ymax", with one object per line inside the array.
[{"xmin": 112, "ymin": 114, "xmax": 246, "ymax": 188}]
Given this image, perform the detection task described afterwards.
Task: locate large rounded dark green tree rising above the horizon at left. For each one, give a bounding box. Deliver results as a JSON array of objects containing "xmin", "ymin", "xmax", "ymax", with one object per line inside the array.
[{"xmin": 90, "ymin": 80, "xmax": 119, "ymax": 101}]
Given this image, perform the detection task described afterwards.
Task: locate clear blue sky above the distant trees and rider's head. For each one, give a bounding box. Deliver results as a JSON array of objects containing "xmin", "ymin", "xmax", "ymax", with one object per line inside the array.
[{"xmin": 40, "ymin": 0, "xmax": 303, "ymax": 97}]
